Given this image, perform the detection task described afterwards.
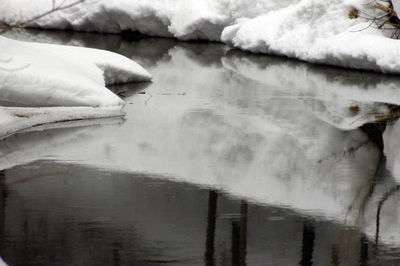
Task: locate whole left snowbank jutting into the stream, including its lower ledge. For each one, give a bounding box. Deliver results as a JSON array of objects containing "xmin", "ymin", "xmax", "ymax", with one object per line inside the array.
[{"xmin": 0, "ymin": 36, "xmax": 151, "ymax": 139}]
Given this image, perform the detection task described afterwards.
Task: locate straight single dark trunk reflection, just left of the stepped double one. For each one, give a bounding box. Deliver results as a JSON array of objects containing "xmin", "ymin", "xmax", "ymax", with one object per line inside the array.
[{"xmin": 204, "ymin": 190, "xmax": 218, "ymax": 266}]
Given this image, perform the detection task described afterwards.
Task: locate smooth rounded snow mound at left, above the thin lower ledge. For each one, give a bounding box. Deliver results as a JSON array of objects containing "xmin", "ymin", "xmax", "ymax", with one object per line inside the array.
[{"xmin": 0, "ymin": 36, "xmax": 151, "ymax": 106}]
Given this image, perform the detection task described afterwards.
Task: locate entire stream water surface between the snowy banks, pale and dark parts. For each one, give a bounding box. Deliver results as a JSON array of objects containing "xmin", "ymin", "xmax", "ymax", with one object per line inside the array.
[{"xmin": 0, "ymin": 32, "xmax": 400, "ymax": 265}]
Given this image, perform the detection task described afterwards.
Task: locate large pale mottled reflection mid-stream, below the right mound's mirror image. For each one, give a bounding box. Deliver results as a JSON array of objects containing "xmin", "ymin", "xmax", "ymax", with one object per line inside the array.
[{"xmin": 0, "ymin": 41, "xmax": 378, "ymax": 229}]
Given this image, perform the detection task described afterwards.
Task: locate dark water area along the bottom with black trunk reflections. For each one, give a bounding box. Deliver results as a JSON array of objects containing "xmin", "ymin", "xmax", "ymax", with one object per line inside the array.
[{"xmin": 0, "ymin": 161, "xmax": 398, "ymax": 265}]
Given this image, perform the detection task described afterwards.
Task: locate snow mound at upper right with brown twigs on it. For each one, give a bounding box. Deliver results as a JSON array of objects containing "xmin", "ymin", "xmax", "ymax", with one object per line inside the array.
[{"xmin": 221, "ymin": 0, "xmax": 400, "ymax": 73}]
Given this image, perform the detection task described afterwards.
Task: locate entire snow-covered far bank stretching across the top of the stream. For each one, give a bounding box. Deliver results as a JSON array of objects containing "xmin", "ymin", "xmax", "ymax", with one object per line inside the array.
[{"xmin": 0, "ymin": 0, "xmax": 400, "ymax": 74}]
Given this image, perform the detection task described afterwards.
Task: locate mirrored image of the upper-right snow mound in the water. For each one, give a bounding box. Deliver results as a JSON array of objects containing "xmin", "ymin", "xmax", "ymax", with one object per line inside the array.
[{"xmin": 222, "ymin": 53, "xmax": 400, "ymax": 129}]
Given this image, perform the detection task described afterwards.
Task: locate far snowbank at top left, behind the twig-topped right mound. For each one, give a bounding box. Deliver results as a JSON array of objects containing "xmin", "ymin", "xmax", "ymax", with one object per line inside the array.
[{"xmin": 0, "ymin": 0, "xmax": 299, "ymax": 41}]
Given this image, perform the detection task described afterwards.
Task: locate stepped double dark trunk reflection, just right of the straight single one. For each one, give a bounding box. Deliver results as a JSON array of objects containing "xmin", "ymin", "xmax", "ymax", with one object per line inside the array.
[{"xmin": 232, "ymin": 200, "xmax": 247, "ymax": 266}]
